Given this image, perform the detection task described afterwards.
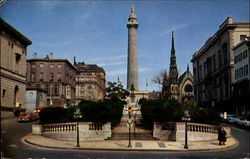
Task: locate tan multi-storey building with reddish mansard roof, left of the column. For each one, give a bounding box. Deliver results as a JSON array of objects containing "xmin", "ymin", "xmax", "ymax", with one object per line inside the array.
[{"xmin": 74, "ymin": 60, "xmax": 106, "ymax": 104}]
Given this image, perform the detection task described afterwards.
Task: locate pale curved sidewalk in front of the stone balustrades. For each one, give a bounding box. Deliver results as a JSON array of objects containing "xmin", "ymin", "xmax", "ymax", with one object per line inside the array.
[{"xmin": 23, "ymin": 134, "xmax": 238, "ymax": 151}]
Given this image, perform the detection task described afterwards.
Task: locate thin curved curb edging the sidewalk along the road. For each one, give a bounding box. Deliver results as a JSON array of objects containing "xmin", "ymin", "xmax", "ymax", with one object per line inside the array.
[{"xmin": 21, "ymin": 136, "xmax": 239, "ymax": 153}]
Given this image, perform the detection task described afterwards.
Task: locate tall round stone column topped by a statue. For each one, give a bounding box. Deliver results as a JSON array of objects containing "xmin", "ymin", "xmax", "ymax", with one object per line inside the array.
[{"xmin": 127, "ymin": 6, "xmax": 138, "ymax": 90}]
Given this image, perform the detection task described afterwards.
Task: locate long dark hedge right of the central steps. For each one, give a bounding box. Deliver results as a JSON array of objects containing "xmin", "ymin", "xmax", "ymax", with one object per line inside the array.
[{"xmin": 139, "ymin": 99, "xmax": 220, "ymax": 128}]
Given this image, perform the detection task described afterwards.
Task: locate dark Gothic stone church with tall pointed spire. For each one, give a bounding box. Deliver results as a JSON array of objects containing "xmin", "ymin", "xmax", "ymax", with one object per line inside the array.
[{"xmin": 162, "ymin": 32, "xmax": 194, "ymax": 103}]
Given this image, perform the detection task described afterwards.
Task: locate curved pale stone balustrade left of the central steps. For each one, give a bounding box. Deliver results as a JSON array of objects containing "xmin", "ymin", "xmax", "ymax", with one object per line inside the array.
[{"xmin": 32, "ymin": 122, "xmax": 111, "ymax": 141}]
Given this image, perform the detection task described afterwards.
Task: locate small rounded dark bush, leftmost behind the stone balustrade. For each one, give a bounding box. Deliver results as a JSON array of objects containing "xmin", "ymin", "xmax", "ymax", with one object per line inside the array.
[{"xmin": 39, "ymin": 107, "xmax": 69, "ymax": 124}]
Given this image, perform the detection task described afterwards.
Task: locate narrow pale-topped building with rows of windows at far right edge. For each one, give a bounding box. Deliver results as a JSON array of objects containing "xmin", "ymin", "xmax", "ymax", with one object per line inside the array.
[{"xmin": 233, "ymin": 37, "xmax": 250, "ymax": 116}]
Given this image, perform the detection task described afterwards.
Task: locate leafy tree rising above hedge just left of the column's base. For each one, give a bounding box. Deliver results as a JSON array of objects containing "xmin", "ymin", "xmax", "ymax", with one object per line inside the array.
[{"xmin": 106, "ymin": 82, "xmax": 129, "ymax": 99}]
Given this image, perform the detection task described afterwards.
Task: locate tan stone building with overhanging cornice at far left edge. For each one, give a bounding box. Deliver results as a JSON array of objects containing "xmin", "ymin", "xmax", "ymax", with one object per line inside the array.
[{"xmin": 0, "ymin": 18, "xmax": 31, "ymax": 118}]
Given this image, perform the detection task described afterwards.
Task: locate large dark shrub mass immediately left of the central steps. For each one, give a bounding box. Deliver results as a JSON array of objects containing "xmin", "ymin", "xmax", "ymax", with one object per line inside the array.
[{"xmin": 79, "ymin": 97, "xmax": 124, "ymax": 126}]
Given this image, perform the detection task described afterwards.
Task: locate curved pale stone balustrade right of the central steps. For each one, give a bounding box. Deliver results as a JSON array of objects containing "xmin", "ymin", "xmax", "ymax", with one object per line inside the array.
[{"xmin": 153, "ymin": 122, "xmax": 231, "ymax": 141}]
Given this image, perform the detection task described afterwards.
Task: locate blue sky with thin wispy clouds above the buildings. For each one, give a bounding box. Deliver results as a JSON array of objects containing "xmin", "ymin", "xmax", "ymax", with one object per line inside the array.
[{"xmin": 0, "ymin": 0, "xmax": 250, "ymax": 91}]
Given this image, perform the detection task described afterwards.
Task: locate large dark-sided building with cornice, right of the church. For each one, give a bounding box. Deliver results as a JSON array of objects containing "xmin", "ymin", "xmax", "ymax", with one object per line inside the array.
[{"xmin": 191, "ymin": 17, "xmax": 250, "ymax": 112}]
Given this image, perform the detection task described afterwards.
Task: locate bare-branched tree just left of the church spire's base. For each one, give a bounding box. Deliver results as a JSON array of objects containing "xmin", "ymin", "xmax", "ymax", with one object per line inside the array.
[{"xmin": 152, "ymin": 70, "xmax": 171, "ymax": 99}]
